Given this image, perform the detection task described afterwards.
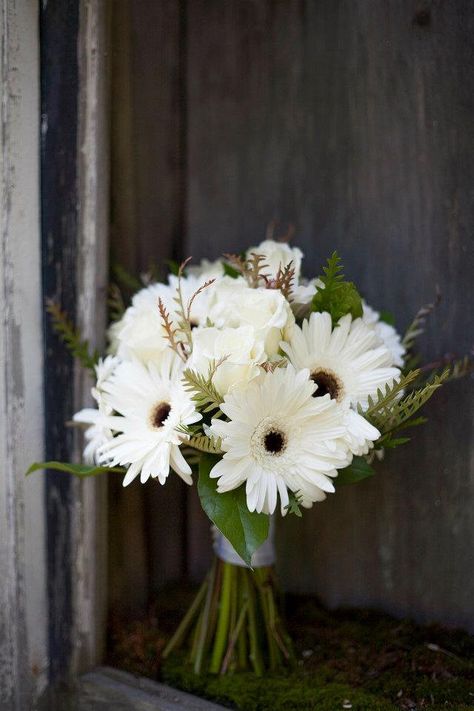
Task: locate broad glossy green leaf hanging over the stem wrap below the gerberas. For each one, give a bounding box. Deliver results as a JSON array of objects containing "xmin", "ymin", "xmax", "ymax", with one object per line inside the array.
[{"xmin": 198, "ymin": 455, "xmax": 270, "ymax": 567}]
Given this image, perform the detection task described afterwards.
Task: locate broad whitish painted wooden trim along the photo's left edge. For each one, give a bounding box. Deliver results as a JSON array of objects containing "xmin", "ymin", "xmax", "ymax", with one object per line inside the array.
[{"xmin": 0, "ymin": 0, "xmax": 48, "ymax": 711}]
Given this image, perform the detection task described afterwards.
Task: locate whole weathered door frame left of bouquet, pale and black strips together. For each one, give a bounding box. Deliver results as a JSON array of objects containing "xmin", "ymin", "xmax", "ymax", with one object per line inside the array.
[{"xmin": 0, "ymin": 0, "xmax": 109, "ymax": 711}]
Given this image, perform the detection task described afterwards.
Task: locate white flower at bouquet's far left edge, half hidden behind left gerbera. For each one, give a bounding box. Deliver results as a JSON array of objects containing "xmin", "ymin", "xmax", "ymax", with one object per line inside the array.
[{"xmin": 73, "ymin": 356, "xmax": 119, "ymax": 464}]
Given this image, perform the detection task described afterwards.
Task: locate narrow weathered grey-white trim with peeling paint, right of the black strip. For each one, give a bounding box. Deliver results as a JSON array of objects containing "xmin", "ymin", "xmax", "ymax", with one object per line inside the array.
[{"xmin": 72, "ymin": 0, "xmax": 109, "ymax": 672}]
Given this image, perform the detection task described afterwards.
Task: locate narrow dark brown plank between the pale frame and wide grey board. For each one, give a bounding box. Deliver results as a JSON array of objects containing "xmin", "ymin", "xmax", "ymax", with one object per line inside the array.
[{"xmin": 109, "ymin": 0, "xmax": 186, "ymax": 615}]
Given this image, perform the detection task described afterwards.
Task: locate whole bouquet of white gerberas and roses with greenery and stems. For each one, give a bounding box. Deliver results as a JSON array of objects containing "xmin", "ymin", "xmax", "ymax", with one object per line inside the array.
[{"xmin": 31, "ymin": 240, "xmax": 466, "ymax": 674}]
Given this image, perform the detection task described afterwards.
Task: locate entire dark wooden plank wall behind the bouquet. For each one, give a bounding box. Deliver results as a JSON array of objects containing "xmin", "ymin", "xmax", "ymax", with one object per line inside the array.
[{"xmin": 110, "ymin": 0, "xmax": 474, "ymax": 629}]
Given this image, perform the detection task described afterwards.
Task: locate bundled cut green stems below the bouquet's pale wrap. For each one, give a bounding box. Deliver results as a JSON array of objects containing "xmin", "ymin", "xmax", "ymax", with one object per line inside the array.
[{"xmin": 163, "ymin": 557, "xmax": 294, "ymax": 676}]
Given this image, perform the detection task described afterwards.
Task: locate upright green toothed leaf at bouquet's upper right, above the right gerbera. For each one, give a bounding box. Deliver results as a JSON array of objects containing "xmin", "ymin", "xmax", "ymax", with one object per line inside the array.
[{"xmin": 312, "ymin": 252, "xmax": 362, "ymax": 326}]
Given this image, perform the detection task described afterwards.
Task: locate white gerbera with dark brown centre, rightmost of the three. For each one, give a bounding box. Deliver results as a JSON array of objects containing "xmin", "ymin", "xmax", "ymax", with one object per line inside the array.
[{"xmin": 281, "ymin": 313, "xmax": 400, "ymax": 455}]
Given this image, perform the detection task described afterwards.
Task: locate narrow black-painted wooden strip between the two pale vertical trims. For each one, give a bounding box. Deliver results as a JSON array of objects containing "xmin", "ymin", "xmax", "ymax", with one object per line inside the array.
[{"xmin": 40, "ymin": 0, "xmax": 79, "ymax": 680}]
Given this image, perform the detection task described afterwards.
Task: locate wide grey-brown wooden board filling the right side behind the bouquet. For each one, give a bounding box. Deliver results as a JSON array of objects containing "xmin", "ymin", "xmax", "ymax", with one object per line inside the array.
[{"xmin": 186, "ymin": 0, "xmax": 474, "ymax": 629}]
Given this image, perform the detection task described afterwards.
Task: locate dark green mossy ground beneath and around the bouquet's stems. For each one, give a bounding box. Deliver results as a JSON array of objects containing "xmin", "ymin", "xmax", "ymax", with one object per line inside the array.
[{"xmin": 109, "ymin": 588, "xmax": 474, "ymax": 711}]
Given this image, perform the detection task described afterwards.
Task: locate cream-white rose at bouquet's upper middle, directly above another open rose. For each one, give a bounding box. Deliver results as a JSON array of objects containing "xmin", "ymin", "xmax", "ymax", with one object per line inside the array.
[{"xmin": 208, "ymin": 277, "xmax": 295, "ymax": 357}]
